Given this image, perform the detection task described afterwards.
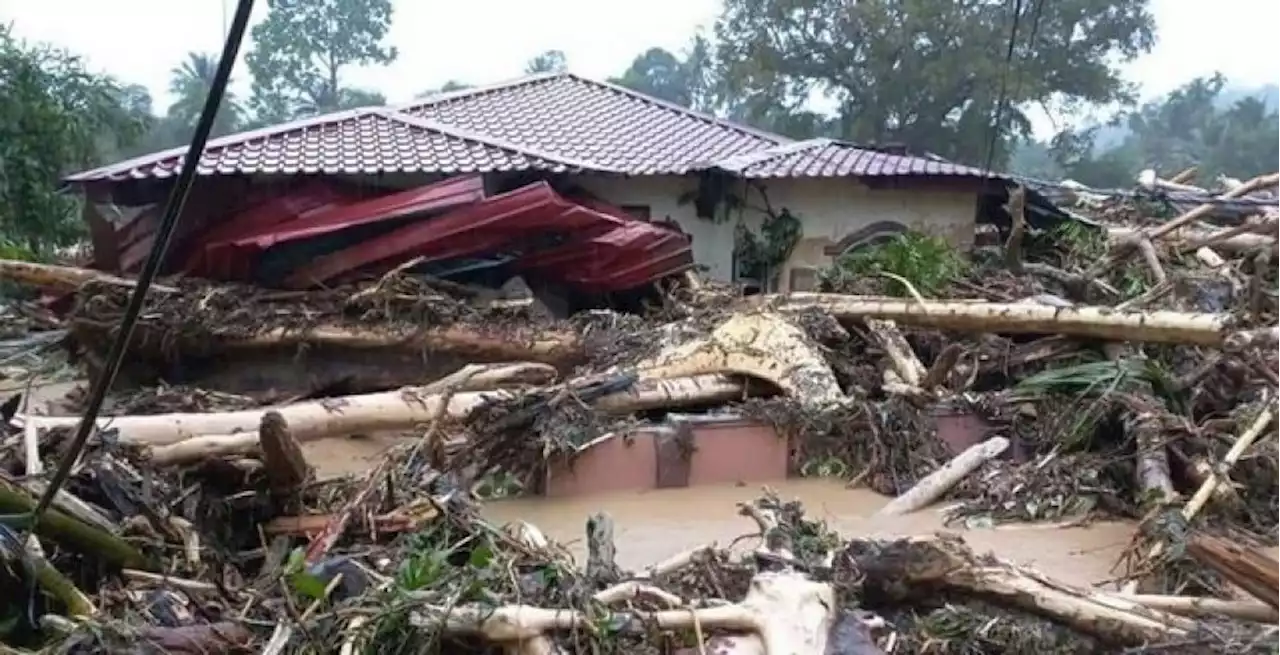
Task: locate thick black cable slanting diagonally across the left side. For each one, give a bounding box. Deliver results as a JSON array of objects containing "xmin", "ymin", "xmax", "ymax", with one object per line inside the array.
[{"xmin": 27, "ymin": 0, "xmax": 253, "ymax": 533}]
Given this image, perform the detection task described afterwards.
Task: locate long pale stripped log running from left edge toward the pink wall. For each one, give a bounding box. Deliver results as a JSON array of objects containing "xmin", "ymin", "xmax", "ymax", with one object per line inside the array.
[{"xmin": 32, "ymin": 375, "xmax": 745, "ymax": 463}]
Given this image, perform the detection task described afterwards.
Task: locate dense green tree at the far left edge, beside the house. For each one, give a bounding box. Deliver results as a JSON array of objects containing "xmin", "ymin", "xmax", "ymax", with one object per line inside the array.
[{"xmin": 0, "ymin": 27, "xmax": 151, "ymax": 255}]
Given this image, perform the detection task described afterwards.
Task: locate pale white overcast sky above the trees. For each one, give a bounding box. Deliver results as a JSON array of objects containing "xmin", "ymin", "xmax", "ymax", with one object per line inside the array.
[{"xmin": 0, "ymin": 0, "xmax": 1280, "ymax": 132}]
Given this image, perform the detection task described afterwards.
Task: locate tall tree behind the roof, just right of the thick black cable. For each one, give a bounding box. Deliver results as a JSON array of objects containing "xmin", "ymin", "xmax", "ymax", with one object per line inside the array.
[{"xmin": 246, "ymin": 0, "xmax": 397, "ymax": 124}]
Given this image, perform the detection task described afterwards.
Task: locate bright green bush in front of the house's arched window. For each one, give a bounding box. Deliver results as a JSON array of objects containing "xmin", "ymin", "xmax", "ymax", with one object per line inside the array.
[{"xmin": 822, "ymin": 232, "xmax": 969, "ymax": 296}]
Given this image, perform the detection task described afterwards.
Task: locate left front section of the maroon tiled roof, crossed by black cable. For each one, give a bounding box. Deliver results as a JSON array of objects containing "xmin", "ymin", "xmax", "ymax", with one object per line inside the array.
[{"xmin": 67, "ymin": 109, "xmax": 580, "ymax": 183}]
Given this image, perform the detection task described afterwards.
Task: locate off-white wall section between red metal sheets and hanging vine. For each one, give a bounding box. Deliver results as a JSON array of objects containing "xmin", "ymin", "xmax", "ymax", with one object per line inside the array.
[{"xmin": 573, "ymin": 175, "xmax": 733, "ymax": 281}]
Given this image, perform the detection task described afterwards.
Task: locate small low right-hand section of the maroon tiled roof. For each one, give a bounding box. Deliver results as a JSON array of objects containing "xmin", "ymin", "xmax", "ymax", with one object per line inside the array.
[{"xmin": 710, "ymin": 138, "xmax": 1000, "ymax": 178}]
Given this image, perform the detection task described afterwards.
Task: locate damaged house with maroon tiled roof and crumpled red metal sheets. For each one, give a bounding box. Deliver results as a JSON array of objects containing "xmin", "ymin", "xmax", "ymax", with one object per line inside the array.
[{"xmin": 67, "ymin": 73, "xmax": 1054, "ymax": 298}]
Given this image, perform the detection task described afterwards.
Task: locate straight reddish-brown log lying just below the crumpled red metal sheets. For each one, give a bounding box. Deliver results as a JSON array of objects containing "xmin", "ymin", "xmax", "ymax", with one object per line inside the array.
[{"xmin": 222, "ymin": 325, "xmax": 584, "ymax": 365}]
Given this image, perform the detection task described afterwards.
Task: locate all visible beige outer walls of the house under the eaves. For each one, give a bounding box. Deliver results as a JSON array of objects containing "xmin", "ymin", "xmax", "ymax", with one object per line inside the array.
[{"xmin": 565, "ymin": 175, "xmax": 978, "ymax": 289}]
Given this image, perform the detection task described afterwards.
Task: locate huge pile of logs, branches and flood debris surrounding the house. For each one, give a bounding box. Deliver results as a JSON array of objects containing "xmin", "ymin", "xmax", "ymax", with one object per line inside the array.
[{"xmin": 0, "ymin": 168, "xmax": 1280, "ymax": 654}]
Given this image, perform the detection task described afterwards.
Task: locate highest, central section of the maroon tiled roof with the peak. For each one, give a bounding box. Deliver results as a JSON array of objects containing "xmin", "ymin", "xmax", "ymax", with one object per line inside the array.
[{"xmin": 401, "ymin": 73, "xmax": 788, "ymax": 175}]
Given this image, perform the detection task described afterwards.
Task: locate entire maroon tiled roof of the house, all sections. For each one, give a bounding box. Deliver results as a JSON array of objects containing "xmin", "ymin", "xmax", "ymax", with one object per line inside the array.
[{"xmin": 67, "ymin": 73, "xmax": 986, "ymax": 183}]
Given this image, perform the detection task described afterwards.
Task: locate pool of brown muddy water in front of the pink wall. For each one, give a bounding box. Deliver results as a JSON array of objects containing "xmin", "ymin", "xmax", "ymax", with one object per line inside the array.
[{"xmin": 485, "ymin": 480, "xmax": 1133, "ymax": 586}]
